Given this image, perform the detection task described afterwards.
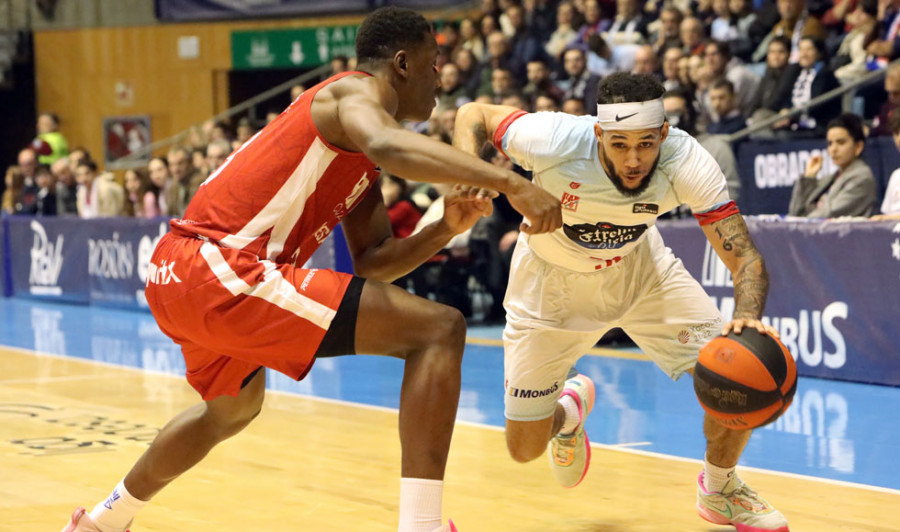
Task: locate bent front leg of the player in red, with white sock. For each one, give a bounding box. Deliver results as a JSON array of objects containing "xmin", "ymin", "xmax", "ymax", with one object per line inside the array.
[{"xmin": 356, "ymin": 281, "xmax": 466, "ymax": 532}]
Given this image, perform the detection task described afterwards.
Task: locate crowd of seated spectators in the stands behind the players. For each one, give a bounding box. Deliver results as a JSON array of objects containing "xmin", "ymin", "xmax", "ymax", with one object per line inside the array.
[{"xmin": 0, "ymin": 0, "xmax": 900, "ymax": 312}]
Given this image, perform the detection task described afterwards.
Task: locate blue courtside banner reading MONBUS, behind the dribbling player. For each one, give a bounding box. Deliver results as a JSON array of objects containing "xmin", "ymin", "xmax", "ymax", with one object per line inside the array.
[{"xmin": 659, "ymin": 218, "xmax": 900, "ymax": 386}]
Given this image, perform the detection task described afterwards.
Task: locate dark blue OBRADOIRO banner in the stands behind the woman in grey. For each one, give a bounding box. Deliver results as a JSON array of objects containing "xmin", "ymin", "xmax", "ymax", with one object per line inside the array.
[{"xmin": 737, "ymin": 137, "xmax": 900, "ymax": 214}]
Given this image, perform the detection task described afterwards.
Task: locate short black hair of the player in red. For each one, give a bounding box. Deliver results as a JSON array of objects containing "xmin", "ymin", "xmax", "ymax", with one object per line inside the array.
[{"xmin": 356, "ymin": 7, "xmax": 432, "ymax": 64}]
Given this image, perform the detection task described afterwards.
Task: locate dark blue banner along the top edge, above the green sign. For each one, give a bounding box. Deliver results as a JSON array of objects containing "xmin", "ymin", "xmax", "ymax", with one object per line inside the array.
[{"xmin": 156, "ymin": 0, "xmax": 460, "ymax": 22}]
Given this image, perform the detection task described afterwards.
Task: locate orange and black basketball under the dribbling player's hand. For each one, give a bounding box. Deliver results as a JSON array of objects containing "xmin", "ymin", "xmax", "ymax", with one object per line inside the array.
[{"xmin": 694, "ymin": 328, "xmax": 797, "ymax": 429}]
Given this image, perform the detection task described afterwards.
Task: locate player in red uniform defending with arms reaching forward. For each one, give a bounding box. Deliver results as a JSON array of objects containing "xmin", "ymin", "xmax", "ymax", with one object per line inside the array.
[{"xmin": 63, "ymin": 8, "xmax": 561, "ymax": 532}]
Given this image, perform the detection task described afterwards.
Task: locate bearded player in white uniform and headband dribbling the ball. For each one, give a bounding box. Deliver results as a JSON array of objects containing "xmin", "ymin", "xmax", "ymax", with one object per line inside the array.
[{"xmin": 454, "ymin": 73, "xmax": 788, "ymax": 532}]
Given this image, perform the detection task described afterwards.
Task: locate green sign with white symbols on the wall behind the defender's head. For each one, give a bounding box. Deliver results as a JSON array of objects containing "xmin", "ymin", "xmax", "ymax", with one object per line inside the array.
[{"xmin": 231, "ymin": 26, "xmax": 357, "ymax": 70}]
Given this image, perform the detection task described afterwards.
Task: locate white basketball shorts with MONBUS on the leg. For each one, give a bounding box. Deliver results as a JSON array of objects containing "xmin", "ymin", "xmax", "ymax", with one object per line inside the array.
[{"xmin": 503, "ymin": 227, "xmax": 724, "ymax": 421}]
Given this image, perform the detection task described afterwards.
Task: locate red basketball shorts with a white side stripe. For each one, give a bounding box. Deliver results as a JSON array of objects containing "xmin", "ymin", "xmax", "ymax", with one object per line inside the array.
[{"xmin": 146, "ymin": 233, "xmax": 353, "ymax": 400}]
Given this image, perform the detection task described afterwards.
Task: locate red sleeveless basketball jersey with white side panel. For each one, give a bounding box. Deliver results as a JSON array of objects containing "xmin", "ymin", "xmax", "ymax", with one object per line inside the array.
[{"xmin": 171, "ymin": 72, "xmax": 377, "ymax": 265}]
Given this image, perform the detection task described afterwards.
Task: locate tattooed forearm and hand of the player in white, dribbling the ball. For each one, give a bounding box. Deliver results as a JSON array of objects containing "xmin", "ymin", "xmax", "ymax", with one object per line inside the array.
[{"xmin": 701, "ymin": 214, "xmax": 778, "ymax": 336}]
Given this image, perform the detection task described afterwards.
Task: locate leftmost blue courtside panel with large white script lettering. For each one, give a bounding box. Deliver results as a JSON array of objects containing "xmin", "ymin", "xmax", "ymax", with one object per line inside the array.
[{"xmin": 7, "ymin": 216, "xmax": 90, "ymax": 303}]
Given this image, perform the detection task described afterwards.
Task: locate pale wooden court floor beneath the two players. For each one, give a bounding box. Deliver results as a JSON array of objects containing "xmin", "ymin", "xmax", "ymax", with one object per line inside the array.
[{"xmin": 0, "ymin": 348, "xmax": 900, "ymax": 532}]
